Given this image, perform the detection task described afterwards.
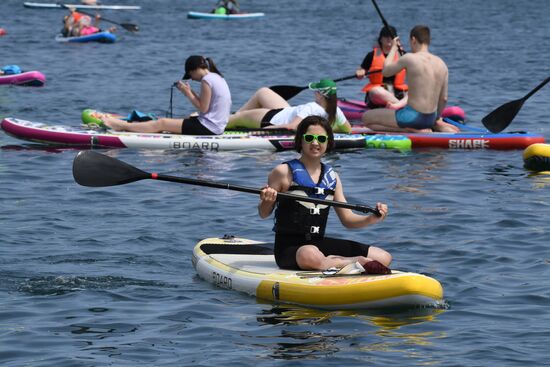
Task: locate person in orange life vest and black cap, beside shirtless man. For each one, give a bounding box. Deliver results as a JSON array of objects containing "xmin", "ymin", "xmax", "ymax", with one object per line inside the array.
[{"xmin": 355, "ymin": 26, "xmax": 409, "ymax": 110}]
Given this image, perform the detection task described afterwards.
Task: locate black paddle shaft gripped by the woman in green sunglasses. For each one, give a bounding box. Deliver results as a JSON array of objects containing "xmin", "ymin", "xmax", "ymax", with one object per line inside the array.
[{"xmin": 153, "ymin": 173, "xmax": 381, "ymax": 216}]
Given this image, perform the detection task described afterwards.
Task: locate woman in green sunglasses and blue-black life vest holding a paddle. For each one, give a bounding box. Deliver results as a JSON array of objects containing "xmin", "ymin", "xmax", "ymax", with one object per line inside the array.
[{"xmin": 258, "ymin": 116, "xmax": 392, "ymax": 274}]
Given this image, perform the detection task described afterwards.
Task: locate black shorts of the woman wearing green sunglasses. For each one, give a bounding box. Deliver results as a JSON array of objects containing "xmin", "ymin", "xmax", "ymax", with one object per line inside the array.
[{"xmin": 274, "ymin": 233, "xmax": 370, "ymax": 270}]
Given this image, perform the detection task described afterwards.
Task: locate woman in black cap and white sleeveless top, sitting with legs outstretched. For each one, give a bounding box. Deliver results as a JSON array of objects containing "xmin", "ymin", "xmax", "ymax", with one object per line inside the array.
[{"xmin": 100, "ymin": 55, "xmax": 231, "ymax": 135}]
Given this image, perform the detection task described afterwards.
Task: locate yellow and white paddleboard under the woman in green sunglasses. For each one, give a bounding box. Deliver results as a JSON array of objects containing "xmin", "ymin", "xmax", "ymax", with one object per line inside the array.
[{"xmin": 193, "ymin": 237, "xmax": 443, "ymax": 310}]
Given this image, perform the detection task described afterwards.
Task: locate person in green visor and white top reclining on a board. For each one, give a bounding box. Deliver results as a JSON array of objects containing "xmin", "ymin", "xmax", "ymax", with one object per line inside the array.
[{"xmin": 227, "ymin": 79, "xmax": 351, "ymax": 133}]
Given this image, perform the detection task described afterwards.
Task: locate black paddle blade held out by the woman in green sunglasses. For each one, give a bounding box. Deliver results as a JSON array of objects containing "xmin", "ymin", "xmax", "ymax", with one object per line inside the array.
[{"xmin": 73, "ymin": 150, "xmax": 151, "ymax": 187}]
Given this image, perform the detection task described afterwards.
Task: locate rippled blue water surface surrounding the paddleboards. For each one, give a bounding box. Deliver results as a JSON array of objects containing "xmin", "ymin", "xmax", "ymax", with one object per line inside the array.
[{"xmin": 0, "ymin": 0, "xmax": 550, "ymax": 366}]
